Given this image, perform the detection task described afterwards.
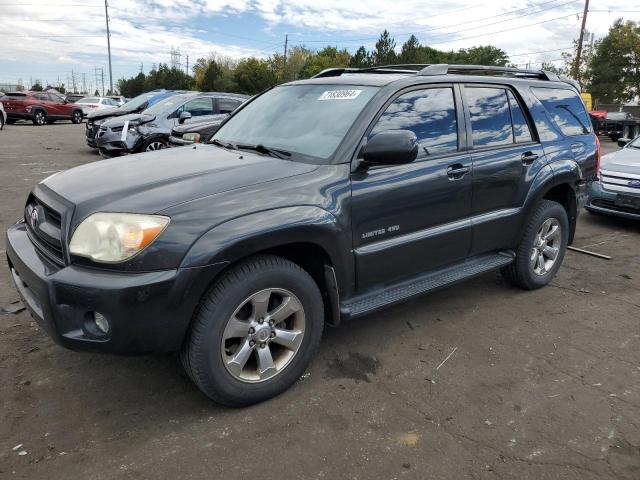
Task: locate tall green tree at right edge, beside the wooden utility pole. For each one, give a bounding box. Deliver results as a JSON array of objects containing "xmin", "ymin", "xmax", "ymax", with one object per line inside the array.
[{"xmin": 586, "ymin": 19, "xmax": 640, "ymax": 103}]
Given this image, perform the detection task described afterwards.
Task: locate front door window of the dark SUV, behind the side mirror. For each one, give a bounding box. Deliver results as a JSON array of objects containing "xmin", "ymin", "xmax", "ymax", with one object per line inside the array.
[{"xmin": 369, "ymin": 88, "xmax": 458, "ymax": 157}]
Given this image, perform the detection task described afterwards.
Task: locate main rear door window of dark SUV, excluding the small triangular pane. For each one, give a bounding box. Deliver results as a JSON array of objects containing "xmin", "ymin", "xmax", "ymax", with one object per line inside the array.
[{"xmin": 465, "ymin": 87, "xmax": 513, "ymax": 147}]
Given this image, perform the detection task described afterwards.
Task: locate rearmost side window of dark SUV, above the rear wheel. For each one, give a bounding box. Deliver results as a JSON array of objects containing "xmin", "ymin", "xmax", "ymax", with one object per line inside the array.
[{"xmin": 531, "ymin": 88, "xmax": 591, "ymax": 136}]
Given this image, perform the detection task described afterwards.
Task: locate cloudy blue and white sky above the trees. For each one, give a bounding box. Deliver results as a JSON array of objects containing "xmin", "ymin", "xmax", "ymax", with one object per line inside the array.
[{"xmin": 0, "ymin": 0, "xmax": 640, "ymax": 90}]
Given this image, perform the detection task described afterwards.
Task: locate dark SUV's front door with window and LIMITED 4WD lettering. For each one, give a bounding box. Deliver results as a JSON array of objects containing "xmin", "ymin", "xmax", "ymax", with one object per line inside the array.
[{"xmin": 352, "ymin": 85, "xmax": 472, "ymax": 291}]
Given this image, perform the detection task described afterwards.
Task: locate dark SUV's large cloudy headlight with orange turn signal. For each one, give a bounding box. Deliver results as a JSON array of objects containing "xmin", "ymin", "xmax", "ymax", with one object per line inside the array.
[{"xmin": 69, "ymin": 213, "xmax": 169, "ymax": 263}]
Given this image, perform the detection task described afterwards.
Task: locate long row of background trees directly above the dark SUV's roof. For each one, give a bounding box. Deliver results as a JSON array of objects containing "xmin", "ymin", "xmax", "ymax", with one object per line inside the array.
[{"xmin": 118, "ymin": 30, "xmax": 509, "ymax": 97}]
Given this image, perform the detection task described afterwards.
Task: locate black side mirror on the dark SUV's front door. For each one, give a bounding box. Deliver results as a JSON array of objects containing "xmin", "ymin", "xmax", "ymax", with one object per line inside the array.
[{"xmin": 362, "ymin": 130, "xmax": 418, "ymax": 165}]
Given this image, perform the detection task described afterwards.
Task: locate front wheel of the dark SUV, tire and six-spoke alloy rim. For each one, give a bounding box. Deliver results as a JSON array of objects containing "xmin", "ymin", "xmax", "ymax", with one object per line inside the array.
[{"xmin": 180, "ymin": 255, "xmax": 324, "ymax": 407}]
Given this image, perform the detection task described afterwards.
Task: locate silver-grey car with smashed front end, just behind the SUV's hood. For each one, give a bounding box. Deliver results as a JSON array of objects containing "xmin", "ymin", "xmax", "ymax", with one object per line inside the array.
[{"xmin": 96, "ymin": 92, "xmax": 248, "ymax": 157}]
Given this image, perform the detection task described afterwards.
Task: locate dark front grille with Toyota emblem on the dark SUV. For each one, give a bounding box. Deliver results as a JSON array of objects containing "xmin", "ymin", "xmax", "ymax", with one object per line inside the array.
[{"xmin": 24, "ymin": 195, "xmax": 64, "ymax": 265}]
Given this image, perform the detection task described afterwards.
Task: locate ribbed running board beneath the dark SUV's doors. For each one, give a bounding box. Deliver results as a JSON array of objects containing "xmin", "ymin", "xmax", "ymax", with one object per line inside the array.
[{"xmin": 340, "ymin": 251, "xmax": 515, "ymax": 318}]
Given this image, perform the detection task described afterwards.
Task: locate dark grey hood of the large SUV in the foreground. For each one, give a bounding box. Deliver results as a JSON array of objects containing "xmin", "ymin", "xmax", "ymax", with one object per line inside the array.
[{"xmin": 44, "ymin": 145, "xmax": 317, "ymax": 218}]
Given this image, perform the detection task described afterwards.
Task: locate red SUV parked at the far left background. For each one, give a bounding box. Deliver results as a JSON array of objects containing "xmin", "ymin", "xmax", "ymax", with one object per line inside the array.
[{"xmin": 0, "ymin": 92, "xmax": 82, "ymax": 125}]
